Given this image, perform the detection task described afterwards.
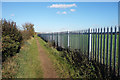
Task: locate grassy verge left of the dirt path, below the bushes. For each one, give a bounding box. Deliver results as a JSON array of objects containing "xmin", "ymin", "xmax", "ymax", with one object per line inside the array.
[{"xmin": 2, "ymin": 38, "xmax": 43, "ymax": 78}]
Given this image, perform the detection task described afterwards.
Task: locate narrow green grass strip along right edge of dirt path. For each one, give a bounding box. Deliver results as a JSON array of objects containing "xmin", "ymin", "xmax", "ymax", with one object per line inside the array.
[{"xmin": 38, "ymin": 37, "xmax": 70, "ymax": 78}]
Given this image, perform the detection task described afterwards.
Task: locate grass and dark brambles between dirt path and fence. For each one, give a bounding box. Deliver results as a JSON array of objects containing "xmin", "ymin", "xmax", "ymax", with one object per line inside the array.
[{"xmin": 39, "ymin": 36, "xmax": 117, "ymax": 79}]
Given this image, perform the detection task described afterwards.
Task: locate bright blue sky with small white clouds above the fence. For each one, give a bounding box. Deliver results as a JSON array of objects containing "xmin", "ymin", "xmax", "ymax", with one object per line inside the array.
[{"xmin": 2, "ymin": 2, "xmax": 118, "ymax": 32}]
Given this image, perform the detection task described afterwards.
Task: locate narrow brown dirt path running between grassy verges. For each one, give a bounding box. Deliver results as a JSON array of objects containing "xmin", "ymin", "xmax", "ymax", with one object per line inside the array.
[{"xmin": 36, "ymin": 38, "xmax": 58, "ymax": 78}]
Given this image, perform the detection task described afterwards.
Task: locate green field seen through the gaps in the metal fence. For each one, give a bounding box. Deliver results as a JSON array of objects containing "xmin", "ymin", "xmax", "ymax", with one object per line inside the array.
[{"xmin": 54, "ymin": 34, "xmax": 119, "ymax": 74}]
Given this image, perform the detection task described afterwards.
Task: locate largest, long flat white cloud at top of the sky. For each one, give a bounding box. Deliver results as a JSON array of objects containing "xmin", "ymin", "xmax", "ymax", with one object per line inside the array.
[{"xmin": 48, "ymin": 4, "xmax": 77, "ymax": 8}]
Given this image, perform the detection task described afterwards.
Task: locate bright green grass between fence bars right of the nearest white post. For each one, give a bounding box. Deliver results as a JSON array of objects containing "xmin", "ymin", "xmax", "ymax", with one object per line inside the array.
[{"xmin": 92, "ymin": 35, "xmax": 119, "ymax": 69}]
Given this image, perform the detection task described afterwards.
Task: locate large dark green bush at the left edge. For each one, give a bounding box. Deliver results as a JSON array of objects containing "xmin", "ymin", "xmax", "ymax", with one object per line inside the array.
[{"xmin": 1, "ymin": 20, "xmax": 22, "ymax": 61}]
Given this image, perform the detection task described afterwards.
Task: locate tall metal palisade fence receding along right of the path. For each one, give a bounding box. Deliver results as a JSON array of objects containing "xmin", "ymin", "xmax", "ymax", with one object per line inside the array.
[{"xmin": 38, "ymin": 26, "xmax": 120, "ymax": 76}]
